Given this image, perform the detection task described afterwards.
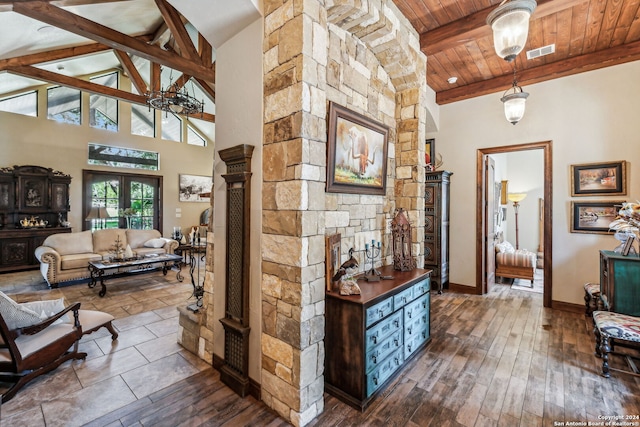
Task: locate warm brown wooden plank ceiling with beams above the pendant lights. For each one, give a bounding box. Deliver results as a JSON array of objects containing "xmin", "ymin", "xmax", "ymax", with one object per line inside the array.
[{"xmin": 393, "ymin": 0, "xmax": 640, "ymax": 104}]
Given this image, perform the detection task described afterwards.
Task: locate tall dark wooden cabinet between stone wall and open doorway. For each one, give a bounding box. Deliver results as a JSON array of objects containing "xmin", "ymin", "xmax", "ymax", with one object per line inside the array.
[{"xmin": 424, "ymin": 171, "xmax": 453, "ymax": 294}]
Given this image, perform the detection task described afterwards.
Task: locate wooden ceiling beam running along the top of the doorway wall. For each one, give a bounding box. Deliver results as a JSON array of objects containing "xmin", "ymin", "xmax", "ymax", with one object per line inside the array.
[{"xmin": 436, "ymin": 41, "xmax": 640, "ymax": 105}]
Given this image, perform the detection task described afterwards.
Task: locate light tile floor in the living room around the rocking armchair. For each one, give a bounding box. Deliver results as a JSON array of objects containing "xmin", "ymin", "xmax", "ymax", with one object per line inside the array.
[{"xmin": 0, "ymin": 268, "xmax": 212, "ymax": 427}]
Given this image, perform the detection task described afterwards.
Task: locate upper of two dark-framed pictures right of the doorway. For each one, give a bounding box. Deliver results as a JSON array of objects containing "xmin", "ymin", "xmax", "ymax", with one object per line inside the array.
[{"xmin": 571, "ymin": 160, "xmax": 627, "ymax": 196}]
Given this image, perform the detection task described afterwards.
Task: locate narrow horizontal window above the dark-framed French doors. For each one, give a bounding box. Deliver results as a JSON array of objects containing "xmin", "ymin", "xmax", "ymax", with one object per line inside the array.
[{"xmin": 88, "ymin": 143, "xmax": 160, "ymax": 171}]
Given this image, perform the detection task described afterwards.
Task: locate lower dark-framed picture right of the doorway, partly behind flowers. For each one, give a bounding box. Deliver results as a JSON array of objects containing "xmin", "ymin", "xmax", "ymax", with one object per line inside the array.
[{"xmin": 571, "ymin": 200, "xmax": 624, "ymax": 234}]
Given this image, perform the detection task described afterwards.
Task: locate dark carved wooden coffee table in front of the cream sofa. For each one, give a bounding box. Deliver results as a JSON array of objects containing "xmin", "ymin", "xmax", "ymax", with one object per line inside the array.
[{"xmin": 89, "ymin": 254, "xmax": 184, "ymax": 297}]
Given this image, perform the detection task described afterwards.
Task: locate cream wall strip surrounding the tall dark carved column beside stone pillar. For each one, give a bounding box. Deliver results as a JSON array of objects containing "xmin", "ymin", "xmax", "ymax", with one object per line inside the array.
[{"xmin": 213, "ymin": 19, "xmax": 263, "ymax": 382}]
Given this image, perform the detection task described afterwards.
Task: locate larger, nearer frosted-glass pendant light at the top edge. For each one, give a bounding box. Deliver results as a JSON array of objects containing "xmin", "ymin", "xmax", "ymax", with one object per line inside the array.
[{"xmin": 487, "ymin": 0, "xmax": 537, "ymax": 62}]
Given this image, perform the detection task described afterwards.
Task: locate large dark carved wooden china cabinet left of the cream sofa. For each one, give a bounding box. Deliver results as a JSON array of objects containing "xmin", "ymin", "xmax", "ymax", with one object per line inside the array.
[{"xmin": 0, "ymin": 166, "xmax": 71, "ymax": 272}]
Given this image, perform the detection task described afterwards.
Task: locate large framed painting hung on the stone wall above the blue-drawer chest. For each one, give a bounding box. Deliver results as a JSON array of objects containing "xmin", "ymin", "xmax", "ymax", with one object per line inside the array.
[{"xmin": 326, "ymin": 102, "xmax": 389, "ymax": 196}]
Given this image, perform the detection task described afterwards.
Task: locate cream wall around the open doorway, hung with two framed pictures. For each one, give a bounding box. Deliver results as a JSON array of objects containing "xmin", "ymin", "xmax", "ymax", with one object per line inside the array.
[{"xmin": 427, "ymin": 61, "xmax": 640, "ymax": 305}]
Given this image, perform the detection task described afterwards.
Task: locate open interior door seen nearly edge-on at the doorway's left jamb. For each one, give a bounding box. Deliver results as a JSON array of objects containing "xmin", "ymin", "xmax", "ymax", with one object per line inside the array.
[{"xmin": 482, "ymin": 156, "xmax": 500, "ymax": 293}]
